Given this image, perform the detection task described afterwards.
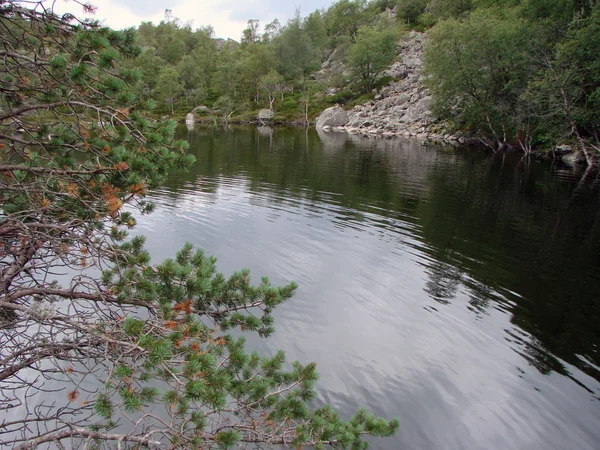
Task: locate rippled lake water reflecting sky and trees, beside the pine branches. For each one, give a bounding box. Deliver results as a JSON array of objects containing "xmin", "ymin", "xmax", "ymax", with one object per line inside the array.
[{"xmin": 139, "ymin": 128, "xmax": 600, "ymax": 449}]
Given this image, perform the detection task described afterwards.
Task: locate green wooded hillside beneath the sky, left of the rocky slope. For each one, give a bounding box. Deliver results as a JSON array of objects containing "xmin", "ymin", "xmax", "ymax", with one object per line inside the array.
[{"xmin": 130, "ymin": 0, "xmax": 406, "ymax": 122}]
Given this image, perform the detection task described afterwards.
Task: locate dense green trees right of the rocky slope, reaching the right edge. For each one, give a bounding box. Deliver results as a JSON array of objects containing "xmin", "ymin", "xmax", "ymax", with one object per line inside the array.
[{"xmin": 425, "ymin": 0, "xmax": 599, "ymax": 155}]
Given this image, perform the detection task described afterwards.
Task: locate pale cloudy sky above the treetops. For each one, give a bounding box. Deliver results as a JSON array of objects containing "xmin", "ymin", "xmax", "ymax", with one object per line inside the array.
[{"xmin": 55, "ymin": 0, "xmax": 335, "ymax": 41}]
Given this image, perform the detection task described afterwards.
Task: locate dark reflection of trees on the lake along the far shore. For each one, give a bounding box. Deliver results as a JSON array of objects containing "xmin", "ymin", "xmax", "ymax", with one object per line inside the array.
[{"xmin": 169, "ymin": 127, "xmax": 600, "ymax": 380}]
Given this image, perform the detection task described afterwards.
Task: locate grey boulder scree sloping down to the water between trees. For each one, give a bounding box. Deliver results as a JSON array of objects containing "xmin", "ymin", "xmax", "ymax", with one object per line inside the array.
[{"xmin": 317, "ymin": 31, "xmax": 465, "ymax": 142}]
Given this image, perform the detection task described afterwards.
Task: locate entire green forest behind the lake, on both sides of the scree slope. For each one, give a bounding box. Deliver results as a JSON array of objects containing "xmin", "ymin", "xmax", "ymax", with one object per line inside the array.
[{"xmin": 130, "ymin": 0, "xmax": 600, "ymax": 160}]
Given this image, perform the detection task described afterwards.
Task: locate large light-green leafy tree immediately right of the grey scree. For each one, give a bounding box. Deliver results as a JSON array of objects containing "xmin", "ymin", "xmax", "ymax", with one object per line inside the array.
[{"xmin": 424, "ymin": 9, "xmax": 529, "ymax": 141}]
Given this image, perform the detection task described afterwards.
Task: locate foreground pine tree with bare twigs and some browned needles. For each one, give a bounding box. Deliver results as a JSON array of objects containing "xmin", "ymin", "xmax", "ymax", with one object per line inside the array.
[{"xmin": 0, "ymin": 1, "xmax": 398, "ymax": 449}]
